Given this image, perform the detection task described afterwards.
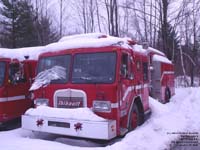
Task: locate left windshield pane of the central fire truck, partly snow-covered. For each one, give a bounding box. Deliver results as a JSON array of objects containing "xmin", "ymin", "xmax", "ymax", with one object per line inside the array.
[{"xmin": 38, "ymin": 55, "xmax": 71, "ymax": 83}]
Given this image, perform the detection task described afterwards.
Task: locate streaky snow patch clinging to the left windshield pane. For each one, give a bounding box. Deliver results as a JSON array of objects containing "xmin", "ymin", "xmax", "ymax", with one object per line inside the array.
[{"xmin": 29, "ymin": 66, "xmax": 66, "ymax": 91}]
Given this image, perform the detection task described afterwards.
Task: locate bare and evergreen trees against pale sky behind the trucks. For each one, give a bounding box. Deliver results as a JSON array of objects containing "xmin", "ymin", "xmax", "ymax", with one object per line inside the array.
[{"xmin": 0, "ymin": 0, "xmax": 200, "ymax": 86}]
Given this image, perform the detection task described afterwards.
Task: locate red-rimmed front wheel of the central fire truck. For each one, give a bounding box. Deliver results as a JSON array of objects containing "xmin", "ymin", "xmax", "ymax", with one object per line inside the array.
[{"xmin": 128, "ymin": 104, "xmax": 140, "ymax": 131}]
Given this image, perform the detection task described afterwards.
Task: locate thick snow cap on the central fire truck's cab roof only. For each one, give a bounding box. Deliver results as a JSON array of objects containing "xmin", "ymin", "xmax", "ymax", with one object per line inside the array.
[{"xmin": 45, "ymin": 33, "xmax": 134, "ymax": 52}]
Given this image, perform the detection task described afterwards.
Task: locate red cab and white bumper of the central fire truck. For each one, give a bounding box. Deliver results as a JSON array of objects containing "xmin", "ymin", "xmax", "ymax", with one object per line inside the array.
[{"xmin": 22, "ymin": 35, "xmax": 173, "ymax": 140}]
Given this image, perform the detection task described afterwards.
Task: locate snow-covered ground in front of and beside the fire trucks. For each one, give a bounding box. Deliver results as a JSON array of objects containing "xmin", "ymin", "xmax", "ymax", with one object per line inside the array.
[{"xmin": 0, "ymin": 87, "xmax": 200, "ymax": 150}]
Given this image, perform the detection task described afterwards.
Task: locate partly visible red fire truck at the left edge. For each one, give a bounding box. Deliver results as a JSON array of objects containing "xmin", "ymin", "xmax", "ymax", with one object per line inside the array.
[{"xmin": 0, "ymin": 57, "xmax": 36, "ymax": 126}]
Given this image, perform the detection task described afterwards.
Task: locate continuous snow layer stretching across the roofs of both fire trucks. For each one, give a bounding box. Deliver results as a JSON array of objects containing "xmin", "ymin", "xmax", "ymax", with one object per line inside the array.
[{"xmin": 0, "ymin": 33, "xmax": 165, "ymax": 60}]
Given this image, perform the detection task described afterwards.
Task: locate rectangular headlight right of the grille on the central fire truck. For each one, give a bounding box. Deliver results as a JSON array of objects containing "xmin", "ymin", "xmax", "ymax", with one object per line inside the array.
[{"xmin": 93, "ymin": 101, "xmax": 111, "ymax": 112}]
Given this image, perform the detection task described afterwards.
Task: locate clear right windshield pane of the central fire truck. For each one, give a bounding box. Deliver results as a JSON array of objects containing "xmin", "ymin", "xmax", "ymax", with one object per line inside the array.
[{"xmin": 72, "ymin": 52, "xmax": 116, "ymax": 83}]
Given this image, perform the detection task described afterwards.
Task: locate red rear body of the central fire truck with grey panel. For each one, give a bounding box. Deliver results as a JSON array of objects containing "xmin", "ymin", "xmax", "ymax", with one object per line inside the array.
[{"xmin": 147, "ymin": 47, "xmax": 175, "ymax": 103}]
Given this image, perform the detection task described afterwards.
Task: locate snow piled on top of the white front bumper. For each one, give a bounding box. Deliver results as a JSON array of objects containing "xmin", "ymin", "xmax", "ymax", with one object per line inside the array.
[{"xmin": 25, "ymin": 106, "xmax": 105, "ymax": 121}]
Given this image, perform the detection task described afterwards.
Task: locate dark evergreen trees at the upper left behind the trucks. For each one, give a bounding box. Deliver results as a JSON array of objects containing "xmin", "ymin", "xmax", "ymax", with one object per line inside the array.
[{"xmin": 0, "ymin": 0, "xmax": 58, "ymax": 48}]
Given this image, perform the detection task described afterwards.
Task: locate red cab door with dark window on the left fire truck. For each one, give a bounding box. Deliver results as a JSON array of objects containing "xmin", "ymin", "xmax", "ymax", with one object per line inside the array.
[{"xmin": 5, "ymin": 62, "xmax": 31, "ymax": 120}]
